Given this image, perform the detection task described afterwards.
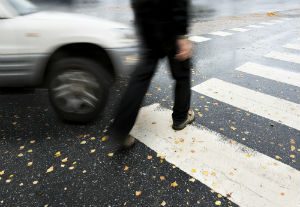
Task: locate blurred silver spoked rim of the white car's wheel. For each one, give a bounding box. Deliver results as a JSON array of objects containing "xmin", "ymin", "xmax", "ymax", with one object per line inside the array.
[{"xmin": 51, "ymin": 70, "xmax": 101, "ymax": 114}]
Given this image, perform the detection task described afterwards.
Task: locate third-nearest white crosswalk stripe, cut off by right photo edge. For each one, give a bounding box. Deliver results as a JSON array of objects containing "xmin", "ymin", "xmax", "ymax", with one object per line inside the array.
[{"xmin": 236, "ymin": 62, "xmax": 300, "ymax": 87}]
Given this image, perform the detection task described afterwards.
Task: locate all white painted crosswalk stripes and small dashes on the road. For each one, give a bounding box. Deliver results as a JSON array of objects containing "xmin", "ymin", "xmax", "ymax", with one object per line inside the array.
[{"xmin": 131, "ymin": 34, "xmax": 300, "ymax": 207}]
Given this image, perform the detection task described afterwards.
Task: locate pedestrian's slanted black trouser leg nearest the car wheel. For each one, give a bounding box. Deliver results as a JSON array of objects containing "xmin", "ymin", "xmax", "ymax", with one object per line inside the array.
[{"xmin": 110, "ymin": 53, "xmax": 159, "ymax": 143}]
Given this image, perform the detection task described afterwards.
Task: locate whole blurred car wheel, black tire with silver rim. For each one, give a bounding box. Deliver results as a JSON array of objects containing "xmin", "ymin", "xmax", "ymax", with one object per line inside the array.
[{"xmin": 48, "ymin": 58, "xmax": 111, "ymax": 123}]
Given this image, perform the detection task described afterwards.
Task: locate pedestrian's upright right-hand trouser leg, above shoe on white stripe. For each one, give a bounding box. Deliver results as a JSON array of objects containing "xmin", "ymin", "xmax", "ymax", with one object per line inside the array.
[{"xmin": 168, "ymin": 53, "xmax": 191, "ymax": 123}]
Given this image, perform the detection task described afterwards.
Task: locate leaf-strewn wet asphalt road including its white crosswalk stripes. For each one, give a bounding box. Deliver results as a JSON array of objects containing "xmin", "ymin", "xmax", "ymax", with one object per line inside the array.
[{"xmin": 0, "ymin": 0, "xmax": 300, "ymax": 207}]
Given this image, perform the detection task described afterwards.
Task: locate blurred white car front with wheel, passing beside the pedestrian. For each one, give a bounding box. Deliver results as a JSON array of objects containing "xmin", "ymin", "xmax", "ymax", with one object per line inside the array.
[{"xmin": 0, "ymin": 0, "xmax": 138, "ymax": 122}]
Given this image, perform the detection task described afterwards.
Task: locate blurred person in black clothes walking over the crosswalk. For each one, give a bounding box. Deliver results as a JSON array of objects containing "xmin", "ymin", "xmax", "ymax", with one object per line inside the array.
[{"xmin": 110, "ymin": 0, "xmax": 195, "ymax": 148}]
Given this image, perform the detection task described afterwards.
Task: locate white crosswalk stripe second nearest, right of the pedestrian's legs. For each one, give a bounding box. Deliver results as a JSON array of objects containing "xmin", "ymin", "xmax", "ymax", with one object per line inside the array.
[{"xmin": 192, "ymin": 78, "xmax": 300, "ymax": 130}]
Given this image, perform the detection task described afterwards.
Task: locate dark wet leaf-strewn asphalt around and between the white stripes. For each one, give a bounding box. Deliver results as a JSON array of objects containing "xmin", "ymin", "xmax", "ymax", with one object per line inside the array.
[{"xmin": 0, "ymin": 0, "xmax": 300, "ymax": 207}]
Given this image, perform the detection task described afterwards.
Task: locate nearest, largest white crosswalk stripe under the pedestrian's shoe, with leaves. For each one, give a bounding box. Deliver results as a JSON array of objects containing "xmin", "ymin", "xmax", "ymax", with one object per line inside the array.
[{"xmin": 131, "ymin": 104, "xmax": 300, "ymax": 207}]
